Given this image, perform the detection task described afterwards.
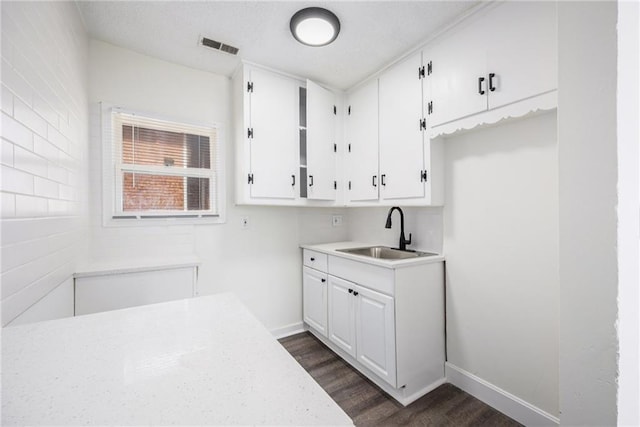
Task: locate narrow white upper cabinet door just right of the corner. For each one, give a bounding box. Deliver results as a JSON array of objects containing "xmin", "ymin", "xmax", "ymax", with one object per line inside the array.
[{"xmin": 346, "ymin": 79, "xmax": 380, "ymax": 202}]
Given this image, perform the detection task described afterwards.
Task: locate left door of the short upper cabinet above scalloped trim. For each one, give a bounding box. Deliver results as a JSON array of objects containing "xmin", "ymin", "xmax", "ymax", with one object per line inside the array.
[{"xmin": 424, "ymin": 22, "xmax": 492, "ymax": 126}]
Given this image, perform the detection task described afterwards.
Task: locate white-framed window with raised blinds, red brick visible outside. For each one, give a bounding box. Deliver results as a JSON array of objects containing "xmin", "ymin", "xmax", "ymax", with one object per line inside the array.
[{"xmin": 105, "ymin": 108, "xmax": 224, "ymax": 222}]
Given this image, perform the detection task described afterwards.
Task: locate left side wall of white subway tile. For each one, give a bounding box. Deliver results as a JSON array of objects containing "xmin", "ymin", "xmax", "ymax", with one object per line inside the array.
[{"xmin": 1, "ymin": 2, "xmax": 88, "ymax": 326}]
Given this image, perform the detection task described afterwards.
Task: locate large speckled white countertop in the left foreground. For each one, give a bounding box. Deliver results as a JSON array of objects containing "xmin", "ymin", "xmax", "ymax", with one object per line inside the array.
[{"xmin": 2, "ymin": 294, "xmax": 352, "ymax": 425}]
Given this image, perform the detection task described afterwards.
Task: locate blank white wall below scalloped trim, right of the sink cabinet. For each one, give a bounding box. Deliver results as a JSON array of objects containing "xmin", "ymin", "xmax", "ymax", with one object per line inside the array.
[{"xmin": 444, "ymin": 112, "xmax": 559, "ymax": 417}]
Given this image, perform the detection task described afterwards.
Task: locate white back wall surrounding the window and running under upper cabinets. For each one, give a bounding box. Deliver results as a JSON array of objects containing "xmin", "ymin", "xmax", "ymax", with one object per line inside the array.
[{"xmin": 89, "ymin": 40, "xmax": 347, "ymax": 333}]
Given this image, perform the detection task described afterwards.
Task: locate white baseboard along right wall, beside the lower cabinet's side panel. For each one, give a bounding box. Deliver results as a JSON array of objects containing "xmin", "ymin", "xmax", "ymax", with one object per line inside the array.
[{"xmin": 445, "ymin": 362, "xmax": 560, "ymax": 426}]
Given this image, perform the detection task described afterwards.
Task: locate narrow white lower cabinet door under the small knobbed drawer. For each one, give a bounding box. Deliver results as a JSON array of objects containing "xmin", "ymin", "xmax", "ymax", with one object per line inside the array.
[{"xmin": 302, "ymin": 267, "xmax": 327, "ymax": 337}]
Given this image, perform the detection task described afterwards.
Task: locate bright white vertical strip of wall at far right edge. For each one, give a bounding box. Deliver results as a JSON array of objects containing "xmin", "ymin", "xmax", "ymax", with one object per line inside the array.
[{"xmin": 617, "ymin": 1, "xmax": 640, "ymax": 426}]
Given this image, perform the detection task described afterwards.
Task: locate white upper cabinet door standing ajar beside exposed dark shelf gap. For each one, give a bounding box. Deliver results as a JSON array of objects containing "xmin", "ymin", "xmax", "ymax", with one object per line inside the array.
[{"xmin": 307, "ymin": 80, "xmax": 336, "ymax": 200}]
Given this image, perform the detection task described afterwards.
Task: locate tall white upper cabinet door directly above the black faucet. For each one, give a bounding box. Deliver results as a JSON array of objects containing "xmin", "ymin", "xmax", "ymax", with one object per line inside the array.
[{"xmin": 379, "ymin": 52, "xmax": 424, "ymax": 200}]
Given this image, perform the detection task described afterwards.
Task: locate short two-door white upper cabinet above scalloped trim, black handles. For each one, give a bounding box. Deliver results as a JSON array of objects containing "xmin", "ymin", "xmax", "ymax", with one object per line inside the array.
[{"xmin": 424, "ymin": 2, "xmax": 557, "ymax": 127}]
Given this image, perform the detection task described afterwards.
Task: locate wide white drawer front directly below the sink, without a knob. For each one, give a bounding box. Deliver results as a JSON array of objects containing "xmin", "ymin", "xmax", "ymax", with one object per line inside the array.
[{"xmin": 328, "ymin": 256, "xmax": 395, "ymax": 296}]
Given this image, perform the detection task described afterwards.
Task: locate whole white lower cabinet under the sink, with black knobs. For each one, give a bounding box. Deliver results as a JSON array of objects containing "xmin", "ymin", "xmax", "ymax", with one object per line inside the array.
[{"xmin": 303, "ymin": 249, "xmax": 445, "ymax": 405}]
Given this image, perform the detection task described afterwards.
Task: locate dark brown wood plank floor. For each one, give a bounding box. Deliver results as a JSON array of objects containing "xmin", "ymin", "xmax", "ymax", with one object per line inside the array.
[{"xmin": 280, "ymin": 332, "xmax": 520, "ymax": 427}]
